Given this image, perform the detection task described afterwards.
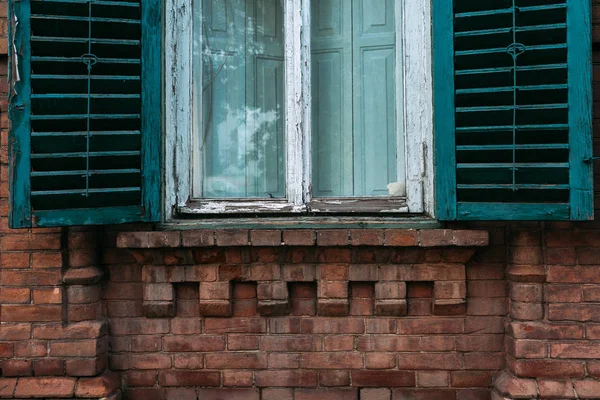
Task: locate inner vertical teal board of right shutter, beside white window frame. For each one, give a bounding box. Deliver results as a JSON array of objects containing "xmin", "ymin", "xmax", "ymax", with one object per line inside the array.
[{"xmin": 432, "ymin": 0, "xmax": 457, "ymax": 220}]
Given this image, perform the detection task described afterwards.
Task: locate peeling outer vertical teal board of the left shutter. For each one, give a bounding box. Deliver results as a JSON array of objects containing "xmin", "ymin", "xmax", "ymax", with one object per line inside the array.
[{"xmin": 8, "ymin": 0, "xmax": 31, "ymax": 228}]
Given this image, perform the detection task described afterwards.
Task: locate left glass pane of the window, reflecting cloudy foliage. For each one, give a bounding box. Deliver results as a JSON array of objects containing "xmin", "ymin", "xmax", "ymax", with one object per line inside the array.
[{"xmin": 194, "ymin": 0, "xmax": 285, "ymax": 198}]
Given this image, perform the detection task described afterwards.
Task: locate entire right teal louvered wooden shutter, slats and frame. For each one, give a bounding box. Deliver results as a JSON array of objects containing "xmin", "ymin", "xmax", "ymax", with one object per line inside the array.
[{"xmin": 432, "ymin": 0, "xmax": 593, "ymax": 220}]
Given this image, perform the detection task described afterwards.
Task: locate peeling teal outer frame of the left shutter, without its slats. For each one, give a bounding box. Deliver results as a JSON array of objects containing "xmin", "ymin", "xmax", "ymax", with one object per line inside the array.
[{"xmin": 8, "ymin": 0, "xmax": 162, "ymax": 228}]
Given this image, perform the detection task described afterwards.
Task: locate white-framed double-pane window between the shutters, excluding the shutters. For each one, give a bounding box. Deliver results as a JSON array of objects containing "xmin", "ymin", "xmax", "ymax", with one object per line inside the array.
[{"xmin": 166, "ymin": 0, "xmax": 433, "ymax": 219}]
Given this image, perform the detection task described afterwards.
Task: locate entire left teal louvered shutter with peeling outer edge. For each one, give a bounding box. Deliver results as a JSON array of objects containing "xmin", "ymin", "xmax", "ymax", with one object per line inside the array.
[{"xmin": 9, "ymin": 0, "xmax": 162, "ymax": 227}]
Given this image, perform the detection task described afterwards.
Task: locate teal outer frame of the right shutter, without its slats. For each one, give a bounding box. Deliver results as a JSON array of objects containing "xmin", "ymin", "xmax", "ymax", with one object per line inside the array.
[{"xmin": 432, "ymin": 0, "xmax": 594, "ymax": 220}]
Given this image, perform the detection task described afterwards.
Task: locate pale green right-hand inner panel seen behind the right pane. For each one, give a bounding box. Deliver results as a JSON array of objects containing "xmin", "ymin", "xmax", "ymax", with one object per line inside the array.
[{"xmin": 352, "ymin": 0, "xmax": 404, "ymax": 197}]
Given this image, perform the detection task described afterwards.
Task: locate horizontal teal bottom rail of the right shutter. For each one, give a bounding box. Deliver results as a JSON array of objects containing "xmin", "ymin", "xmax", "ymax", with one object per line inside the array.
[{"xmin": 457, "ymin": 203, "xmax": 570, "ymax": 221}]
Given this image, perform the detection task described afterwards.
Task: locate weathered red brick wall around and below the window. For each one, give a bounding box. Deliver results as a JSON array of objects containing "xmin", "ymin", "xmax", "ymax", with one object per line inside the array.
[{"xmin": 0, "ymin": 1, "xmax": 600, "ymax": 400}]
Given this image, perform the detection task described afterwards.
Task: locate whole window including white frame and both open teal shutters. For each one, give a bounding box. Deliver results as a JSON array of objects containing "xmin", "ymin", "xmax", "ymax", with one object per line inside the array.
[{"xmin": 8, "ymin": 0, "xmax": 594, "ymax": 227}]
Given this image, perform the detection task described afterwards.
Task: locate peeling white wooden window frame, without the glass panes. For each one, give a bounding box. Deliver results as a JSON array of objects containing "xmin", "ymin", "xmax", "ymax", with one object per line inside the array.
[{"xmin": 163, "ymin": 0, "xmax": 435, "ymax": 221}]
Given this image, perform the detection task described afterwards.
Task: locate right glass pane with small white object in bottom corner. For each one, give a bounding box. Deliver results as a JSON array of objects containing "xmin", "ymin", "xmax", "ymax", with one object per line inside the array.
[{"xmin": 311, "ymin": 0, "xmax": 405, "ymax": 197}]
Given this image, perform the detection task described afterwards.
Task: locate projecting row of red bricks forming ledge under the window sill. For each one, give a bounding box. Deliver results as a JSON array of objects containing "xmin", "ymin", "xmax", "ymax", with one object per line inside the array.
[{"xmin": 117, "ymin": 229, "xmax": 489, "ymax": 249}]
